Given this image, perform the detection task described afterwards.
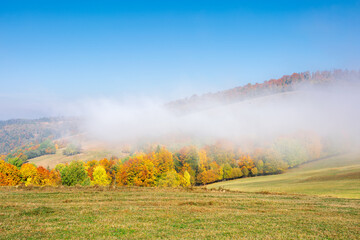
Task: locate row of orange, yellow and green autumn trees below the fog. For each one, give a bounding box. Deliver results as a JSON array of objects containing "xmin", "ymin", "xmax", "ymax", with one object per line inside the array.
[{"xmin": 0, "ymin": 134, "xmax": 326, "ymax": 187}]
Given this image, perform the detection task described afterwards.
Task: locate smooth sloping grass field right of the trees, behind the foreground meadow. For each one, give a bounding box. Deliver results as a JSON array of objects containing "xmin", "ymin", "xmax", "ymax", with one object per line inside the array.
[{"xmin": 207, "ymin": 154, "xmax": 360, "ymax": 199}]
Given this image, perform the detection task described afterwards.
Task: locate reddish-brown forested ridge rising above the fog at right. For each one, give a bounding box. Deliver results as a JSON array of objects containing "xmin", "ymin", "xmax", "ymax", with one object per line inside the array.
[{"xmin": 167, "ymin": 70, "xmax": 360, "ymax": 113}]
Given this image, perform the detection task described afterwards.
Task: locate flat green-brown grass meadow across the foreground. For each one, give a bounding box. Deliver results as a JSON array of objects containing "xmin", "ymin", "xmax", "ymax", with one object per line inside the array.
[{"xmin": 0, "ymin": 188, "xmax": 360, "ymax": 239}]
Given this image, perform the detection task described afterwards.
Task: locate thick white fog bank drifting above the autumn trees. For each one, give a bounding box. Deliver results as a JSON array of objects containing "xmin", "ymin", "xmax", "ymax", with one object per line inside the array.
[{"xmin": 64, "ymin": 83, "xmax": 360, "ymax": 150}]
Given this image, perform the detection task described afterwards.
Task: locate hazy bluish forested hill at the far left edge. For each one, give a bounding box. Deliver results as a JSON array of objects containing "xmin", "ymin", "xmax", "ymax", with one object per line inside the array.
[{"xmin": 0, "ymin": 118, "xmax": 77, "ymax": 154}]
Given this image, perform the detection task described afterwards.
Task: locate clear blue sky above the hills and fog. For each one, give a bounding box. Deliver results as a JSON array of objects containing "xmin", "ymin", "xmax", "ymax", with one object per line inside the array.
[{"xmin": 0, "ymin": 0, "xmax": 360, "ymax": 119}]
